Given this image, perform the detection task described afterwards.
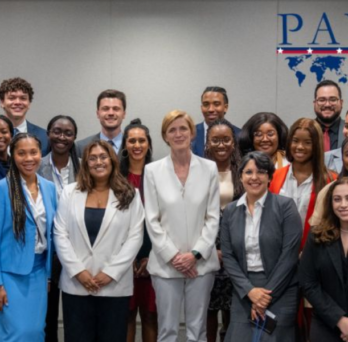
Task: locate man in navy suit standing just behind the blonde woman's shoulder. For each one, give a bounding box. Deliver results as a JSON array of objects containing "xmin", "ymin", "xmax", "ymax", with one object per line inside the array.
[{"xmin": 191, "ymin": 87, "xmax": 240, "ymax": 157}]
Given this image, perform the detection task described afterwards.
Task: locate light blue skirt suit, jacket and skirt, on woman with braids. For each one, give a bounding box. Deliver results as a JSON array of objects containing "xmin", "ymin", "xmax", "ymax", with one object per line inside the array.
[{"xmin": 0, "ymin": 176, "xmax": 57, "ymax": 342}]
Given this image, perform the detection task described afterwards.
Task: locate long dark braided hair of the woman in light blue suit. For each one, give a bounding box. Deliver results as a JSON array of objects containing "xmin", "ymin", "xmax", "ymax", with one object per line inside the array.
[{"xmin": 6, "ymin": 133, "xmax": 41, "ymax": 243}]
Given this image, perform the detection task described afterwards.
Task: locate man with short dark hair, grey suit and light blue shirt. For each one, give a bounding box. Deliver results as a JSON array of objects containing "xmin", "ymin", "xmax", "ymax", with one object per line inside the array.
[{"xmin": 76, "ymin": 89, "xmax": 126, "ymax": 158}]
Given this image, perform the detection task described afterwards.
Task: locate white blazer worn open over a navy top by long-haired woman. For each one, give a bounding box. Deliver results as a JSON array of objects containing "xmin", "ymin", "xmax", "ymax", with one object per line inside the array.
[{"xmin": 54, "ymin": 183, "xmax": 144, "ymax": 297}]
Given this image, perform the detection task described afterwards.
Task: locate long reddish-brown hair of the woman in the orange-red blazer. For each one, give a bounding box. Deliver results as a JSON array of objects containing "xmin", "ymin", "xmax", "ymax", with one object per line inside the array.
[{"xmin": 286, "ymin": 118, "xmax": 333, "ymax": 194}]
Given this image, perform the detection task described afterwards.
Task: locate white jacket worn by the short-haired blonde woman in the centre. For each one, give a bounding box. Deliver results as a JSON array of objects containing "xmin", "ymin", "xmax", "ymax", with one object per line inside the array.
[{"xmin": 144, "ymin": 153, "xmax": 220, "ymax": 278}]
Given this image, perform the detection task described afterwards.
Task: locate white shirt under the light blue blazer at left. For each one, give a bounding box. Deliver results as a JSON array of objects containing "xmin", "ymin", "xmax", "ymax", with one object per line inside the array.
[{"xmin": 22, "ymin": 178, "xmax": 47, "ymax": 254}]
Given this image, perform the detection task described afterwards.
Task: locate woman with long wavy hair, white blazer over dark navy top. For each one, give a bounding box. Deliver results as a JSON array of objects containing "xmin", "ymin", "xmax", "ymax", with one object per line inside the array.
[{"xmin": 54, "ymin": 141, "xmax": 144, "ymax": 342}]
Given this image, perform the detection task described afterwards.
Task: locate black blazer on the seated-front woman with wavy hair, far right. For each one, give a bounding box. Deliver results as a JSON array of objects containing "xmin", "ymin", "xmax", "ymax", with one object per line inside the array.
[{"xmin": 299, "ymin": 233, "xmax": 348, "ymax": 328}]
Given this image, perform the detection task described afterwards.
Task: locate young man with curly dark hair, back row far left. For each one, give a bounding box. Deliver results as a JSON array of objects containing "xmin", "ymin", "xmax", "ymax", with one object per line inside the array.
[{"xmin": 0, "ymin": 77, "xmax": 48, "ymax": 156}]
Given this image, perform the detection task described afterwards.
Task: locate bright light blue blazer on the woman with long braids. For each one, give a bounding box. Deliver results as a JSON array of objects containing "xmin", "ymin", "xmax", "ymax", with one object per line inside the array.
[{"xmin": 0, "ymin": 175, "xmax": 57, "ymax": 285}]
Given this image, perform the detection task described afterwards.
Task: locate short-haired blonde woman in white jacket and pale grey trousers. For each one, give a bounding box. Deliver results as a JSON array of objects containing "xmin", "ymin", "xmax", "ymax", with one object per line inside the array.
[{"xmin": 144, "ymin": 110, "xmax": 220, "ymax": 342}]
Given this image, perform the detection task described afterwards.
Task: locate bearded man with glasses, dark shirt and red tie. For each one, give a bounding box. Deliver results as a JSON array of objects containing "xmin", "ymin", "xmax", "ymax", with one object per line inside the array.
[{"xmin": 313, "ymin": 80, "xmax": 344, "ymax": 152}]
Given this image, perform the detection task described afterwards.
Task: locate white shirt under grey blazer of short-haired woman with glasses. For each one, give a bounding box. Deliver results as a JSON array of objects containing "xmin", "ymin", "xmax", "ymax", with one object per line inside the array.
[{"xmin": 237, "ymin": 191, "xmax": 268, "ymax": 272}]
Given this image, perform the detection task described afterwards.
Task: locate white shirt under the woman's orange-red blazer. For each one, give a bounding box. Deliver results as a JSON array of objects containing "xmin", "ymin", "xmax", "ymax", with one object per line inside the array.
[{"xmin": 279, "ymin": 165, "xmax": 313, "ymax": 229}]
